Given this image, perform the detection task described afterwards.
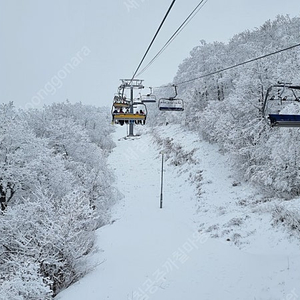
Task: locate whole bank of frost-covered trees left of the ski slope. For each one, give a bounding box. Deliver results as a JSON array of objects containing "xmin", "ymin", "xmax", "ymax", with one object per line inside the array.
[{"xmin": 0, "ymin": 102, "xmax": 117, "ymax": 300}]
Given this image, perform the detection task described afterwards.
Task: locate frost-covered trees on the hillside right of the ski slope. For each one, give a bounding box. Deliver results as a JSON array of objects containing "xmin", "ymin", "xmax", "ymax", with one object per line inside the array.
[{"xmin": 154, "ymin": 16, "xmax": 300, "ymax": 199}]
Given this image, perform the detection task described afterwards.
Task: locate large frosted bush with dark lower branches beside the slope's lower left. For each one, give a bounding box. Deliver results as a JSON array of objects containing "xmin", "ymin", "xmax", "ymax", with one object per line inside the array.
[{"xmin": 0, "ymin": 191, "xmax": 96, "ymax": 292}]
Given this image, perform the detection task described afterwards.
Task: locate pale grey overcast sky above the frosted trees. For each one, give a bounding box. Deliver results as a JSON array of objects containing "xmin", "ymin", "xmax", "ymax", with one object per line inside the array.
[{"xmin": 0, "ymin": 0, "xmax": 300, "ymax": 108}]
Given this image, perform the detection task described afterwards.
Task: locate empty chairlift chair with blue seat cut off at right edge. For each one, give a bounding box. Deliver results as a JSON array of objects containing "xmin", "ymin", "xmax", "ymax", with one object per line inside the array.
[{"xmin": 262, "ymin": 83, "xmax": 300, "ymax": 127}]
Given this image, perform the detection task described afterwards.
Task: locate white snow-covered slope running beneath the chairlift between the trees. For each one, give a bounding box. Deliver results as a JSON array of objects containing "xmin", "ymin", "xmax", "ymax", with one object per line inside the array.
[{"xmin": 56, "ymin": 126, "xmax": 300, "ymax": 300}]
